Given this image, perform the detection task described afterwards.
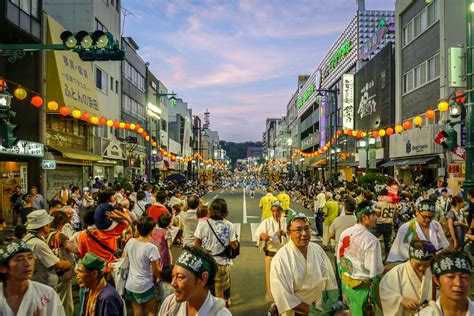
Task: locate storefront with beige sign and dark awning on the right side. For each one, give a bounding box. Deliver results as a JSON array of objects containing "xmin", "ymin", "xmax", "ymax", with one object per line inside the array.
[{"xmin": 381, "ymin": 124, "xmax": 444, "ymax": 185}]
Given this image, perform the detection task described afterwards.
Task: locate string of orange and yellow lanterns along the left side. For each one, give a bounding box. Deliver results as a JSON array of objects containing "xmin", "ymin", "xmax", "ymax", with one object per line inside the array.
[{"xmin": 0, "ymin": 78, "xmax": 227, "ymax": 168}]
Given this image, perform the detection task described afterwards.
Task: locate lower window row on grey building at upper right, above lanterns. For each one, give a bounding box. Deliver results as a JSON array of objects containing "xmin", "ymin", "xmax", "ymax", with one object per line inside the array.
[{"xmin": 402, "ymin": 53, "xmax": 440, "ymax": 95}]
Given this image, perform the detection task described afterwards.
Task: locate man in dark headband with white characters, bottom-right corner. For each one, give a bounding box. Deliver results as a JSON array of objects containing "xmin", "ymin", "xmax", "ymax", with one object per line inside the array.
[{"xmin": 418, "ymin": 250, "xmax": 474, "ymax": 316}]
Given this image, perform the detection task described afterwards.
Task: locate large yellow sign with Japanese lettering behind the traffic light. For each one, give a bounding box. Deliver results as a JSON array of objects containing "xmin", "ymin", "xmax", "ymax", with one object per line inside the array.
[{"xmin": 46, "ymin": 16, "xmax": 101, "ymax": 115}]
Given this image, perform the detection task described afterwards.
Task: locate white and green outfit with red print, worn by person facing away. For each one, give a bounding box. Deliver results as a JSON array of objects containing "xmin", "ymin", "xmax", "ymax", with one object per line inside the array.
[{"xmin": 336, "ymin": 224, "xmax": 384, "ymax": 316}]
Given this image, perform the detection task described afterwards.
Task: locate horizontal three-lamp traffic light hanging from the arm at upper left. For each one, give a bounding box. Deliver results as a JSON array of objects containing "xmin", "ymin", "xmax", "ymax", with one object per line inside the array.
[{"xmin": 61, "ymin": 31, "xmax": 125, "ymax": 61}]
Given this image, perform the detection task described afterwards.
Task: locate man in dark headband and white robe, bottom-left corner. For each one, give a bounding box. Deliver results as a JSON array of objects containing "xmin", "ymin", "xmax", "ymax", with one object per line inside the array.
[{"xmin": 0, "ymin": 240, "xmax": 66, "ymax": 316}]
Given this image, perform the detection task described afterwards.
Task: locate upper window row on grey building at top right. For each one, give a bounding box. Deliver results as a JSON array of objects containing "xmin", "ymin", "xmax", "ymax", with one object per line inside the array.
[{"xmin": 402, "ymin": 0, "xmax": 440, "ymax": 47}]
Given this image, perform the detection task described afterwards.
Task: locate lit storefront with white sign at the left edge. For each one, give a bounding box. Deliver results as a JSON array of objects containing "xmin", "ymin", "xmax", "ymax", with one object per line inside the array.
[{"xmin": 0, "ymin": 140, "xmax": 44, "ymax": 222}]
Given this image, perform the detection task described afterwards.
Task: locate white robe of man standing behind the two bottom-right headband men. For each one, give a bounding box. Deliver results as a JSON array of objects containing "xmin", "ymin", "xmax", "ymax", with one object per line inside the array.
[{"xmin": 387, "ymin": 218, "xmax": 449, "ymax": 262}]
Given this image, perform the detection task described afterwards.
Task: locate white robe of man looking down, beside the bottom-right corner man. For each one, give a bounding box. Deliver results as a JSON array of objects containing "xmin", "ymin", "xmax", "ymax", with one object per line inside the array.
[{"xmin": 379, "ymin": 261, "xmax": 432, "ymax": 316}]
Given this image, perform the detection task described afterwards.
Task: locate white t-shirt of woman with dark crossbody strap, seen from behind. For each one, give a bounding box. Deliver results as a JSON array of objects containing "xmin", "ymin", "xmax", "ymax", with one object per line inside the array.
[{"xmin": 194, "ymin": 218, "xmax": 237, "ymax": 265}]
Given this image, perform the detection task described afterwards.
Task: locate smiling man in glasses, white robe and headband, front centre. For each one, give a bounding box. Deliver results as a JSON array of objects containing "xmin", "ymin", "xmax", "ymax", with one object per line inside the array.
[{"xmin": 270, "ymin": 212, "xmax": 338, "ymax": 316}]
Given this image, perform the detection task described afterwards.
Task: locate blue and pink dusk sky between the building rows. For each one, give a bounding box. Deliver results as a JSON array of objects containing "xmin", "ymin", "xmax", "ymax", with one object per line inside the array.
[{"xmin": 122, "ymin": 0, "xmax": 395, "ymax": 142}]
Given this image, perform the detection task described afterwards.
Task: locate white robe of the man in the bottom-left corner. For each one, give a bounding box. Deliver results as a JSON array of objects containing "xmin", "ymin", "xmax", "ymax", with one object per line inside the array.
[{"xmin": 0, "ymin": 280, "xmax": 66, "ymax": 316}]
